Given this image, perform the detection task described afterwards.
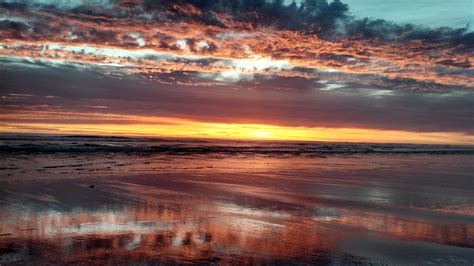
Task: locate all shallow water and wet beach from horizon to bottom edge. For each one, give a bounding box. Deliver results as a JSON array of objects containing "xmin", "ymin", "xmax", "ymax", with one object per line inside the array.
[{"xmin": 0, "ymin": 138, "xmax": 474, "ymax": 265}]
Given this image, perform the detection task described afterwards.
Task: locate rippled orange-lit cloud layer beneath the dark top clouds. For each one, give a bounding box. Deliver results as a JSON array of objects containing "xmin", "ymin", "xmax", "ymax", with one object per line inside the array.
[{"xmin": 0, "ymin": 6, "xmax": 474, "ymax": 91}]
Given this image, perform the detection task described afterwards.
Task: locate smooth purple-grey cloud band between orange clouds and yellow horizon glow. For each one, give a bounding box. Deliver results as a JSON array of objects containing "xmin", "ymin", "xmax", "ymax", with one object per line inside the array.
[{"xmin": 0, "ymin": 62, "xmax": 474, "ymax": 134}]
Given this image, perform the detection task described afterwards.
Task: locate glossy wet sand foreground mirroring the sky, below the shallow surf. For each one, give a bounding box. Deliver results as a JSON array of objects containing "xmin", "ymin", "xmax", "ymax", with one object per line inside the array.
[{"xmin": 0, "ymin": 154, "xmax": 474, "ymax": 265}]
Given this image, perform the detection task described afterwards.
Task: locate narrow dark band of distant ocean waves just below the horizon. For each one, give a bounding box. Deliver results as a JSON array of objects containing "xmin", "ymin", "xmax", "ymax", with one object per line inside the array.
[{"xmin": 0, "ymin": 135, "xmax": 474, "ymax": 156}]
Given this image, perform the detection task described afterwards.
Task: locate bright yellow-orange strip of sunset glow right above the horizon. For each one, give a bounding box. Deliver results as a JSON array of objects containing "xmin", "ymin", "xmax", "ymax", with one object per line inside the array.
[{"xmin": 0, "ymin": 112, "xmax": 474, "ymax": 145}]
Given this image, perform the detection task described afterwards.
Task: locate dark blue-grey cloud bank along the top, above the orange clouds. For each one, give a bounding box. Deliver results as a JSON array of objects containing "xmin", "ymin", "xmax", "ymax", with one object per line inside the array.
[{"xmin": 0, "ymin": 0, "xmax": 474, "ymax": 49}]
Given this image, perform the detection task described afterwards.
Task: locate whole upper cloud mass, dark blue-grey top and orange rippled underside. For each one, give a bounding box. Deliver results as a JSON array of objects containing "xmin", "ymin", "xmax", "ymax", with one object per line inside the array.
[{"xmin": 0, "ymin": 0, "xmax": 474, "ymax": 91}]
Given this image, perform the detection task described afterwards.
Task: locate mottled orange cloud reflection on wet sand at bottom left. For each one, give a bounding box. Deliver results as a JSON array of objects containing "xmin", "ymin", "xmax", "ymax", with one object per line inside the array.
[{"xmin": 1, "ymin": 200, "xmax": 337, "ymax": 262}]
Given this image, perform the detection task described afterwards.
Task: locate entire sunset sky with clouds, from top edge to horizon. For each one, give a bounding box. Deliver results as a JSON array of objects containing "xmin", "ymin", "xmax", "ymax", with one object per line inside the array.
[{"xmin": 0, "ymin": 0, "xmax": 474, "ymax": 144}]
